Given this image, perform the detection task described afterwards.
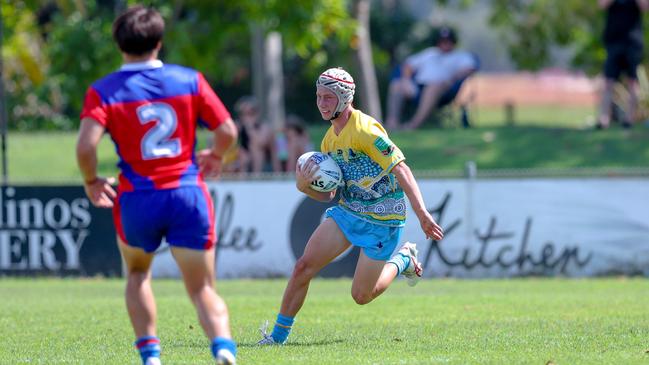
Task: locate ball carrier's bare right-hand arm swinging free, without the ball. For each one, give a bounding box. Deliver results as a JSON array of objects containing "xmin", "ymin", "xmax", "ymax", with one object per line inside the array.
[{"xmin": 392, "ymin": 161, "xmax": 444, "ymax": 241}]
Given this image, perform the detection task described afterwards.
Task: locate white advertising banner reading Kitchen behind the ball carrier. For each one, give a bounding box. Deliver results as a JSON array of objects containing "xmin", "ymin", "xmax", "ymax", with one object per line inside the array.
[{"xmin": 149, "ymin": 178, "xmax": 649, "ymax": 278}]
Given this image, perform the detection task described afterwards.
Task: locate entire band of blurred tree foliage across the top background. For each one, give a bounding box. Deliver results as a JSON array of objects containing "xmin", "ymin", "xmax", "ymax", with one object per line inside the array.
[{"xmin": 0, "ymin": 0, "xmax": 636, "ymax": 130}]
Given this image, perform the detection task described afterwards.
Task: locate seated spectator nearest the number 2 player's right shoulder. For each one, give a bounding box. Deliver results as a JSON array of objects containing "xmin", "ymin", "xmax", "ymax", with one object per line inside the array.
[{"xmin": 235, "ymin": 96, "xmax": 281, "ymax": 173}]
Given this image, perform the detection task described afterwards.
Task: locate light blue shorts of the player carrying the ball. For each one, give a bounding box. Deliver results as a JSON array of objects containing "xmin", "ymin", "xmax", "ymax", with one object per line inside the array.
[{"xmin": 326, "ymin": 205, "xmax": 403, "ymax": 261}]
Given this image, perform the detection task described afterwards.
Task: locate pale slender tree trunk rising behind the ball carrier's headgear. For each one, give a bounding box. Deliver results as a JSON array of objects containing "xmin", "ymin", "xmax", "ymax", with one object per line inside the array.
[{"xmin": 354, "ymin": 0, "xmax": 382, "ymax": 121}]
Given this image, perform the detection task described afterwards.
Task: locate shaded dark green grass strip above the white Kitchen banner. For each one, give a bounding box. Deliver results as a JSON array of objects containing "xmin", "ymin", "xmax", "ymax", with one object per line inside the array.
[{"xmin": 393, "ymin": 127, "xmax": 649, "ymax": 170}]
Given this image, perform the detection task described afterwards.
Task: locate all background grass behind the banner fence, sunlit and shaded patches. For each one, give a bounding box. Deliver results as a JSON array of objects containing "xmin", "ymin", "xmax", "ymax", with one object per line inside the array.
[{"xmin": 8, "ymin": 107, "xmax": 649, "ymax": 183}]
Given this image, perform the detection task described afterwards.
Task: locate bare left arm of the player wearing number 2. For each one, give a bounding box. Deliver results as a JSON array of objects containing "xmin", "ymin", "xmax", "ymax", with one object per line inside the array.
[{"xmin": 77, "ymin": 117, "xmax": 117, "ymax": 208}]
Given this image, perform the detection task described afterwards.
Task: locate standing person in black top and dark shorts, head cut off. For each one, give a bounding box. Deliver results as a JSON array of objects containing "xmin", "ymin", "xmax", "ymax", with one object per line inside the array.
[{"xmin": 597, "ymin": 0, "xmax": 649, "ymax": 129}]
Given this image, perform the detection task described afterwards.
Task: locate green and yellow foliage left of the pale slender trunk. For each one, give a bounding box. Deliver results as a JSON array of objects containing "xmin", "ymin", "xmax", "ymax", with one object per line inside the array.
[{"xmin": 1, "ymin": 0, "xmax": 354, "ymax": 129}]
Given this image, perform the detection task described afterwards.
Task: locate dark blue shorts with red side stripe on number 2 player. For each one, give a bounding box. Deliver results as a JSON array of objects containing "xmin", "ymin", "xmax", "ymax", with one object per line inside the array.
[{"xmin": 113, "ymin": 184, "xmax": 216, "ymax": 253}]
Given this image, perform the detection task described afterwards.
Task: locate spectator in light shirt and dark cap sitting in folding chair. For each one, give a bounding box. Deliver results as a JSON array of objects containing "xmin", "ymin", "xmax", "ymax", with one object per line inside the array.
[{"xmin": 385, "ymin": 27, "xmax": 478, "ymax": 129}]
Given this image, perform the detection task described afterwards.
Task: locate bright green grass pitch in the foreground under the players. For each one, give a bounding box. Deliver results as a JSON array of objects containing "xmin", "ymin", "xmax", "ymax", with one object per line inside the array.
[{"xmin": 0, "ymin": 279, "xmax": 649, "ymax": 365}]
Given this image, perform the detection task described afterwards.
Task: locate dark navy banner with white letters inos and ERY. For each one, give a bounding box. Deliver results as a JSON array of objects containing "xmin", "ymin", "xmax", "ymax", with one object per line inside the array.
[{"xmin": 0, "ymin": 186, "xmax": 121, "ymax": 276}]
